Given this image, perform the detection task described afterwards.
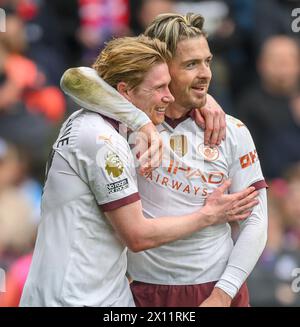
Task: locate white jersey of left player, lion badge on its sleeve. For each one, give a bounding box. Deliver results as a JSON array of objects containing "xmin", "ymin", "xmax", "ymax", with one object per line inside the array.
[{"xmin": 20, "ymin": 110, "xmax": 139, "ymax": 306}]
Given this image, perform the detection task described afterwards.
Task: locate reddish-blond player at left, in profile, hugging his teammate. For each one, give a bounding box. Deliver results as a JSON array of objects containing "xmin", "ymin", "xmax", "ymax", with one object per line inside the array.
[{"xmin": 20, "ymin": 36, "xmax": 257, "ymax": 306}]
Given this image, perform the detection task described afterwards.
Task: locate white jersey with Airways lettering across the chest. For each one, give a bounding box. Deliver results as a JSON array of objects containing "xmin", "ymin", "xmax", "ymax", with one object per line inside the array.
[{"xmin": 128, "ymin": 114, "xmax": 266, "ymax": 285}]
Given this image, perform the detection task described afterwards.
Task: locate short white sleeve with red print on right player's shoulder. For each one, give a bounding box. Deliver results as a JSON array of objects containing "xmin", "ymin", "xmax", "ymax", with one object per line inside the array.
[{"xmin": 229, "ymin": 120, "xmax": 267, "ymax": 193}]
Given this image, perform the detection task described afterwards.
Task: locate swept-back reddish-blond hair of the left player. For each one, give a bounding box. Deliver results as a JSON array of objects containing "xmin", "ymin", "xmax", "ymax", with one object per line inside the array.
[{"xmin": 92, "ymin": 35, "xmax": 171, "ymax": 89}]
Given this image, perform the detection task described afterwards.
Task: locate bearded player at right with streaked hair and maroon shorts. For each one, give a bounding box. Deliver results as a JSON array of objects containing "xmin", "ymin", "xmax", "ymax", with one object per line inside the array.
[{"xmin": 62, "ymin": 14, "xmax": 267, "ymax": 306}]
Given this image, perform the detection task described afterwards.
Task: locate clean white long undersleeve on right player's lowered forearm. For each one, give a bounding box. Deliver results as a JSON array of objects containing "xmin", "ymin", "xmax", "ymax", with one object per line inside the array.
[{"xmin": 216, "ymin": 189, "xmax": 268, "ymax": 298}]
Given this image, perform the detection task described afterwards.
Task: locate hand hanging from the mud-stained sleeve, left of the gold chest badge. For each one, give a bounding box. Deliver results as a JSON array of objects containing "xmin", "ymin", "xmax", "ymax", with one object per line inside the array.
[{"xmin": 136, "ymin": 123, "xmax": 163, "ymax": 174}]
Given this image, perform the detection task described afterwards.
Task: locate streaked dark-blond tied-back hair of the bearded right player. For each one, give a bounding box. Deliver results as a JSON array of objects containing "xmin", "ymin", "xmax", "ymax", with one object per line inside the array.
[{"xmin": 144, "ymin": 13, "xmax": 206, "ymax": 55}]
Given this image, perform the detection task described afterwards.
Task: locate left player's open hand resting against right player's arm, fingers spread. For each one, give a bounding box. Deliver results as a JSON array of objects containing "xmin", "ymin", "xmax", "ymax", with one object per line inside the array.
[{"xmin": 202, "ymin": 180, "xmax": 258, "ymax": 226}]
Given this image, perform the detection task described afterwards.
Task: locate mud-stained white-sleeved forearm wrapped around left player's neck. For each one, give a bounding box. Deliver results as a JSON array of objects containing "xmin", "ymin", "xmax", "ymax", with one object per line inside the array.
[{"xmin": 60, "ymin": 67, "xmax": 151, "ymax": 131}]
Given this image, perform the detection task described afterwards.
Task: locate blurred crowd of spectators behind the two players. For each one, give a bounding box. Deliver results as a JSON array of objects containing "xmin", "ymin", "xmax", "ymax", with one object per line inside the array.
[{"xmin": 0, "ymin": 0, "xmax": 300, "ymax": 306}]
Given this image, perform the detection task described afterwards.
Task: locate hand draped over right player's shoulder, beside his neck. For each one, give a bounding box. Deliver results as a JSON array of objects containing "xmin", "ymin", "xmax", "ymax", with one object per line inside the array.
[{"xmin": 195, "ymin": 94, "xmax": 226, "ymax": 145}]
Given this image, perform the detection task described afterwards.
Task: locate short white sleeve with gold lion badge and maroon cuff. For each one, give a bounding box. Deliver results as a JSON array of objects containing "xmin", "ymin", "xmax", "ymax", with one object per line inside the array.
[{"xmin": 75, "ymin": 118, "xmax": 140, "ymax": 211}]
